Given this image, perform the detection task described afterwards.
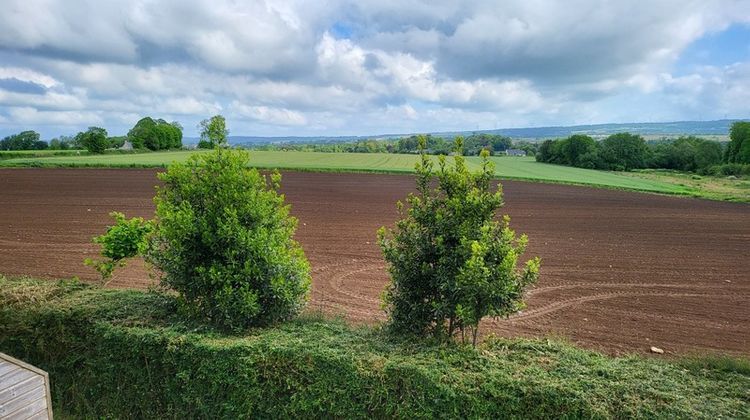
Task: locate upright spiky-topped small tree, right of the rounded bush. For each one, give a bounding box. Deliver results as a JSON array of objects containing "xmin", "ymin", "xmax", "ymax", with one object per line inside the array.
[{"xmin": 378, "ymin": 137, "xmax": 540, "ymax": 344}]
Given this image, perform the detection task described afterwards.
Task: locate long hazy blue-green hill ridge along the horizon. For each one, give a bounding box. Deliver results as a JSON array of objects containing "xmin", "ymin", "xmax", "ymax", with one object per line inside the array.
[{"xmin": 183, "ymin": 120, "xmax": 738, "ymax": 145}]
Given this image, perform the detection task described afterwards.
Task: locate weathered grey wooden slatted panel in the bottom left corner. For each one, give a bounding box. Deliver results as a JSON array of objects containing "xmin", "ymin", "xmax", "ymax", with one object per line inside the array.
[{"xmin": 0, "ymin": 353, "xmax": 52, "ymax": 420}]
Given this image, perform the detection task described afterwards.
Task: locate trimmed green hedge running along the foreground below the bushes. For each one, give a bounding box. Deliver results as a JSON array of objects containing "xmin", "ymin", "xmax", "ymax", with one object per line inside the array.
[{"xmin": 0, "ymin": 276, "xmax": 750, "ymax": 418}]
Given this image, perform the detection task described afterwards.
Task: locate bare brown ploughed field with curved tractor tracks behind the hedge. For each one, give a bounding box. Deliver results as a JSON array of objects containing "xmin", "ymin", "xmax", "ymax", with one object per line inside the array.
[{"xmin": 0, "ymin": 169, "xmax": 750, "ymax": 355}]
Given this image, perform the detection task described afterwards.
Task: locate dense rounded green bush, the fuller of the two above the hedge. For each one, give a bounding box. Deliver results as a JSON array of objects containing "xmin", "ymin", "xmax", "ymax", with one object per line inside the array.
[{"xmin": 146, "ymin": 149, "xmax": 310, "ymax": 329}]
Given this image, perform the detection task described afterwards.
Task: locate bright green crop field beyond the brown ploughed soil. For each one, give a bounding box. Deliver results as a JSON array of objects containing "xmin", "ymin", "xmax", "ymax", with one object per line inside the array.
[{"xmin": 0, "ymin": 151, "xmax": 694, "ymax": 195}]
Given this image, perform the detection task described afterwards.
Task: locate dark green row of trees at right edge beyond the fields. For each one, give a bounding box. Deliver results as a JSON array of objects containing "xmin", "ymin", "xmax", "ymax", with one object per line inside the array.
[{"xmin": 536, "ymin": 122, "xmax": 750, "ymax": 175}]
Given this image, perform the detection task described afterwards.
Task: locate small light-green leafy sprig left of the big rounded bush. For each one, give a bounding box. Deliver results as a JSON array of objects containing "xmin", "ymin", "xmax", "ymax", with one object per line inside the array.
[{"xmin": 84, "ymin": 212, "xmax": 154, "ymax": 283}]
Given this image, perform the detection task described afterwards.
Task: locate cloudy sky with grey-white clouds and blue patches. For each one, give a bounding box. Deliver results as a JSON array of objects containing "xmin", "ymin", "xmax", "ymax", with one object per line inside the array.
[{"xmin": 0, "ymin": 0, "xmax": 750, "ymax": 139}]
